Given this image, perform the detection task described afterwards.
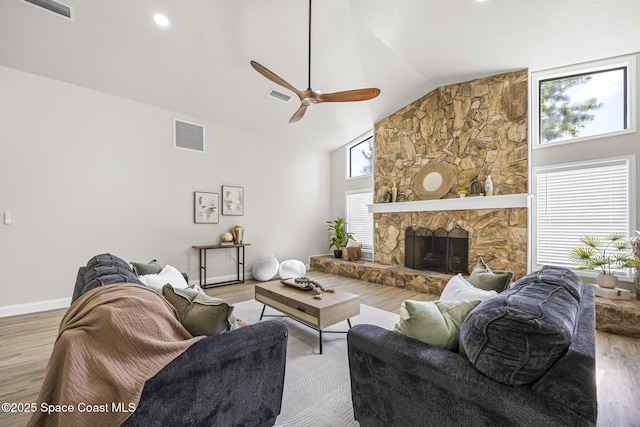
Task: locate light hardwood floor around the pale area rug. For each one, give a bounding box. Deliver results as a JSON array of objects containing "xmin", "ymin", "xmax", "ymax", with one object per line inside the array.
[{"xmin": 0, "ymin": 272, "xmax": 640, "ymax": 427}]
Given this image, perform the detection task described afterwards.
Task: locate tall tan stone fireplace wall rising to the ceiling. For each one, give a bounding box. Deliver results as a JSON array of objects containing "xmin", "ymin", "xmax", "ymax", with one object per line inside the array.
[{"xmin": 371, "ymin": 70, "xmax": 528, "ymax": 278}]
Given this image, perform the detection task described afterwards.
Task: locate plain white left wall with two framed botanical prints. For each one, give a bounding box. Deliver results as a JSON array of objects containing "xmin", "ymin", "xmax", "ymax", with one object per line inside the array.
[{"xmin": 0, "ymin": 67, "xmax": 331, "ymax": 312}]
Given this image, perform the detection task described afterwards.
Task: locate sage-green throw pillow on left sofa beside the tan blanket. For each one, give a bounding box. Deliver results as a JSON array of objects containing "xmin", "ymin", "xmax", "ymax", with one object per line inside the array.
[{"xmin": 162, "ymin": 284, "xmax": 233, "ymax": 337}]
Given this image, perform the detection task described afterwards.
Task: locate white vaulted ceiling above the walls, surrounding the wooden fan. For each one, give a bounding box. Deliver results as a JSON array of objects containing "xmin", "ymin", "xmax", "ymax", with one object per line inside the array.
[{"xmin": 0, "ymin": 0, "xmax": 640, "ymax": 151}]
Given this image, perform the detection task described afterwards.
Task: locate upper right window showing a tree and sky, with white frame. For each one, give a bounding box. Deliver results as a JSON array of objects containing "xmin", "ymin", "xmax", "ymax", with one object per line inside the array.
[{"xmin": 531, "ymin": 56, "xmax": 635, "ymax": 148}]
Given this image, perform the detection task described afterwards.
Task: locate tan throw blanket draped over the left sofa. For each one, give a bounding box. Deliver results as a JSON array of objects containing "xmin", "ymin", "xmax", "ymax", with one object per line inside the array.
[{"xmin": 29, "ymin": 283, "xmax": 204, "ymax": 427}]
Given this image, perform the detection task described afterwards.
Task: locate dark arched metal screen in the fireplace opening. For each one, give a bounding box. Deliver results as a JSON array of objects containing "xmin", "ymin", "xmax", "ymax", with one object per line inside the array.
[{"xmin": 404, "ymin": 227, "xmax": 469, "ymax": 274}]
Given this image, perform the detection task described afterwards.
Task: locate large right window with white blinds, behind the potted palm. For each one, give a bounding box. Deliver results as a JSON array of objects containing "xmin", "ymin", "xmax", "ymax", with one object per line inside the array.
[{"xmin": 532, "ymin": 155, "xmax": 635, "ymax": 279}]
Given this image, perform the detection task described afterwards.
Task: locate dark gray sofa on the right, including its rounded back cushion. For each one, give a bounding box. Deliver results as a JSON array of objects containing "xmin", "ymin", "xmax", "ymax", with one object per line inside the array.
[{"xmin": 348, "ymin": 267, "xmax": 597, "ymax": 427}]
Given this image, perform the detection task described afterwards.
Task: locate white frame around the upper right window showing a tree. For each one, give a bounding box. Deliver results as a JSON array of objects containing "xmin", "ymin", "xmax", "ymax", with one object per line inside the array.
[{"xmin": 529, "ymin": 55, "xmax": 637, "ymax": 150}]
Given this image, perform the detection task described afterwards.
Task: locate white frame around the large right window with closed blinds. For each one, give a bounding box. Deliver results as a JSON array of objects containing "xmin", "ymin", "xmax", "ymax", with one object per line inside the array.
[{"xmin": 530, "ymin": 154, "xmax": 636, "ymax": 282}]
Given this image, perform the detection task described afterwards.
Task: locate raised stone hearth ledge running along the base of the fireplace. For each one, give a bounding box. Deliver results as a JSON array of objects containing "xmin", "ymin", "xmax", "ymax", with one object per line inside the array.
[{"xmin": 310, "ymin": 255, "xmax": 640, "ymax": 338}]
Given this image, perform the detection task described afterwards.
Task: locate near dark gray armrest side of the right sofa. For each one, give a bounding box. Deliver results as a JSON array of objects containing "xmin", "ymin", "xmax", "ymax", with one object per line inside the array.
[{"xmin": 347, "ymin": 325, "xmax": 589, "ymax": 427}]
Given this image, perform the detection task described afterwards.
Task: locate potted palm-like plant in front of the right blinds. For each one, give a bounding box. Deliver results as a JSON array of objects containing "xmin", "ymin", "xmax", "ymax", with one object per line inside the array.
[{"xmin": 569, "ymin": 232, "xmax": 640, "ymax": 288}]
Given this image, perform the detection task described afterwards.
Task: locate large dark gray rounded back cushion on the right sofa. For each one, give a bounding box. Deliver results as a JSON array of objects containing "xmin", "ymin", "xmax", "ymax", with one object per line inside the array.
[{"xmin": 460, "ymin": 266, "xmax": 583, "ymax": 386}]
